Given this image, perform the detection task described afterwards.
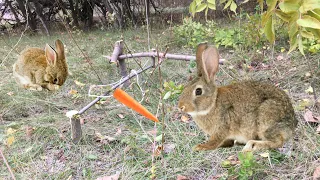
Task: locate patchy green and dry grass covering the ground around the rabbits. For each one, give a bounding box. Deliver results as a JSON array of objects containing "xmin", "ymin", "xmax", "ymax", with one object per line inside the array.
[{"xmin": 0, "ymin": 24, "xmax": 320, "ymax": 179}]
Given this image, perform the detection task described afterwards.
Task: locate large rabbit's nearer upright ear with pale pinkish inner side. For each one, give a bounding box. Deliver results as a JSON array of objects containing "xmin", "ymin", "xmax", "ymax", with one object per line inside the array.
[{"xmin": 202, "ymin": 46, "xmax": 219, "ymax": 82}]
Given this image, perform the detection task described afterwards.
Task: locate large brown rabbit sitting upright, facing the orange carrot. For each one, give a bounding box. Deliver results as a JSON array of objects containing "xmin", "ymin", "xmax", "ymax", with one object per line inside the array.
[{"xmin": 179, "ymin": 43, "xmax": 298, "ymax": 151}]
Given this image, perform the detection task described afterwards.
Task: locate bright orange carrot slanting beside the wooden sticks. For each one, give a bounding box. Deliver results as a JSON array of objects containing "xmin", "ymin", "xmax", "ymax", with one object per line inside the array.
[{"xmin": 113, "ymin": 88, "xmax": 159, "ymax": 122}]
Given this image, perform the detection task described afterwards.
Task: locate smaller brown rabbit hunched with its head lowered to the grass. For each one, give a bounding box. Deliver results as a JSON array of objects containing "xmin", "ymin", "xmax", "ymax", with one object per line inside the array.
[{"xmin": 13, "ymin": 39, "xmax": 68, "ymax": 91}]
